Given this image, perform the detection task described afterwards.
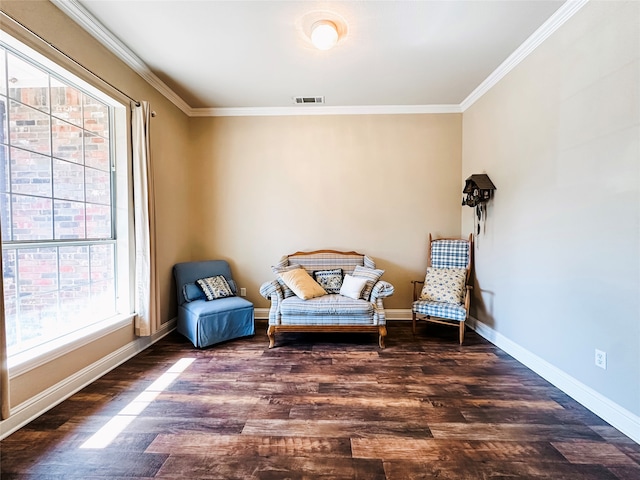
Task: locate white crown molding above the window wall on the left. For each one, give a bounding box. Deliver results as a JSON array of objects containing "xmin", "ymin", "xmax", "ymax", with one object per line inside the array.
[{"xmin": 49, "ymin": 0, "xmax": 192, "ymax": 116}]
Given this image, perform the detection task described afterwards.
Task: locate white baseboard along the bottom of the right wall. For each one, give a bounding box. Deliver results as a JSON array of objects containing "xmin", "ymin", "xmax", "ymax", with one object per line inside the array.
[{"xmin": 467, "ymin": 318, "xmax": 640, "ymax": 443}]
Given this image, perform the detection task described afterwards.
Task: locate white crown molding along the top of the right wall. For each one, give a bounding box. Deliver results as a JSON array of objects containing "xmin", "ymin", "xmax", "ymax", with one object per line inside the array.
[{"xmin": 460, "ymin": 0, "xmax": 589, "ymax": 112}]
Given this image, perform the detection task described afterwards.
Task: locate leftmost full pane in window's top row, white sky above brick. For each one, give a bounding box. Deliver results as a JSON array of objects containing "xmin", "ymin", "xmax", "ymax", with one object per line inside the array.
[{"xmin": 7, "ymin": 53, "xmax": 49, "ymax": 113}]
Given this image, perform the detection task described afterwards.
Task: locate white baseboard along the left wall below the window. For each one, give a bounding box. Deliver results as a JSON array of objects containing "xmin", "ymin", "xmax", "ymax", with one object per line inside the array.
[{"xmin": 0, "ymin": 318, "xmax": 176, "ymax": 440}]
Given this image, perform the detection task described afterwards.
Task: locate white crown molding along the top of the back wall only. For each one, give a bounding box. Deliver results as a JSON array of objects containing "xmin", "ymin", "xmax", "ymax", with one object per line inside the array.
[{"xmin": 191, "ymin": 105, "xmax": 462, "ymax": 117}]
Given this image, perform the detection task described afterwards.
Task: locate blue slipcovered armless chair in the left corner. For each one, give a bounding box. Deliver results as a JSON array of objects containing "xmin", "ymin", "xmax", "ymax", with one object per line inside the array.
[{"xmin": 173, "ymin": 260, "xmax": 255, "ymax": 348}]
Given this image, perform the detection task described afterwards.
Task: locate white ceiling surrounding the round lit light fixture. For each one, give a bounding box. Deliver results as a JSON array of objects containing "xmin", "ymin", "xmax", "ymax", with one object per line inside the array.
[{"xmin": 52, "ymin": 0, "xmax": 571, "ymax": 114}]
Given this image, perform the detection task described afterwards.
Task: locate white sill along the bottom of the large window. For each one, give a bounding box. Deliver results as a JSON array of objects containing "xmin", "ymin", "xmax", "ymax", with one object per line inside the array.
[{"xmin": 8, "ymin": 313, "xmax": 135, "ymax": 378}]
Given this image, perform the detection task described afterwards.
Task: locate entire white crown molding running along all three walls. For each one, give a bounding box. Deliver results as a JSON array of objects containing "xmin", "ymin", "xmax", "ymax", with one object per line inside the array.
[{"xmin": 50, "ymin": 0, "xmax": 589, "ymax": 117}]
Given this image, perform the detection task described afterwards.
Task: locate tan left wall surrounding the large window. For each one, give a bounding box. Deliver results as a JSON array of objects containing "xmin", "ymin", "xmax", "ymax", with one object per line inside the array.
[{"xmin": 0, "ymin": 0, "xmax": 190, "ymax": 408}]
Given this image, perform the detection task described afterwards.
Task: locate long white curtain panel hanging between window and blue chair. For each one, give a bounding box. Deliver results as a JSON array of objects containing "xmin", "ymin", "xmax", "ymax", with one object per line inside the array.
[{"xmin": 131, "ymin": 101, "xmax": 160, "ymax": 337}]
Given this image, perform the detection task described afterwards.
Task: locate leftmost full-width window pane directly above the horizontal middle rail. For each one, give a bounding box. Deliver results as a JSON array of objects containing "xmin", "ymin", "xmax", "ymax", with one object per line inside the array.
[{"xmin": 11, "ymin": 195, "xmax": 53, "ymax": 241}]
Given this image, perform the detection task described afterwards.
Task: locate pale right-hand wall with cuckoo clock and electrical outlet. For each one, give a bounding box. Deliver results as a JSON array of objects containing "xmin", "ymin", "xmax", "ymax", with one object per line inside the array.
[{"xmin": 462, "ymin": 2, "xmax": 640, "ymax": 415}]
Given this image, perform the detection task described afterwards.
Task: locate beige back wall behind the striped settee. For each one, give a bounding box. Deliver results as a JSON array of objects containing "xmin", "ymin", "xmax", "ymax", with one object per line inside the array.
[{"xmin": 190, "ymin": 114, "xmax": 462, "ymax": 309}]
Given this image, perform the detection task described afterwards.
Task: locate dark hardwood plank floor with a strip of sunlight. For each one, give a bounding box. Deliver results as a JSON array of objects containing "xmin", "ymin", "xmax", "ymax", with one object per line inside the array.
[{"xmin": 0, "ymin": 321, "xmax": 640, "ymax": 480}]
